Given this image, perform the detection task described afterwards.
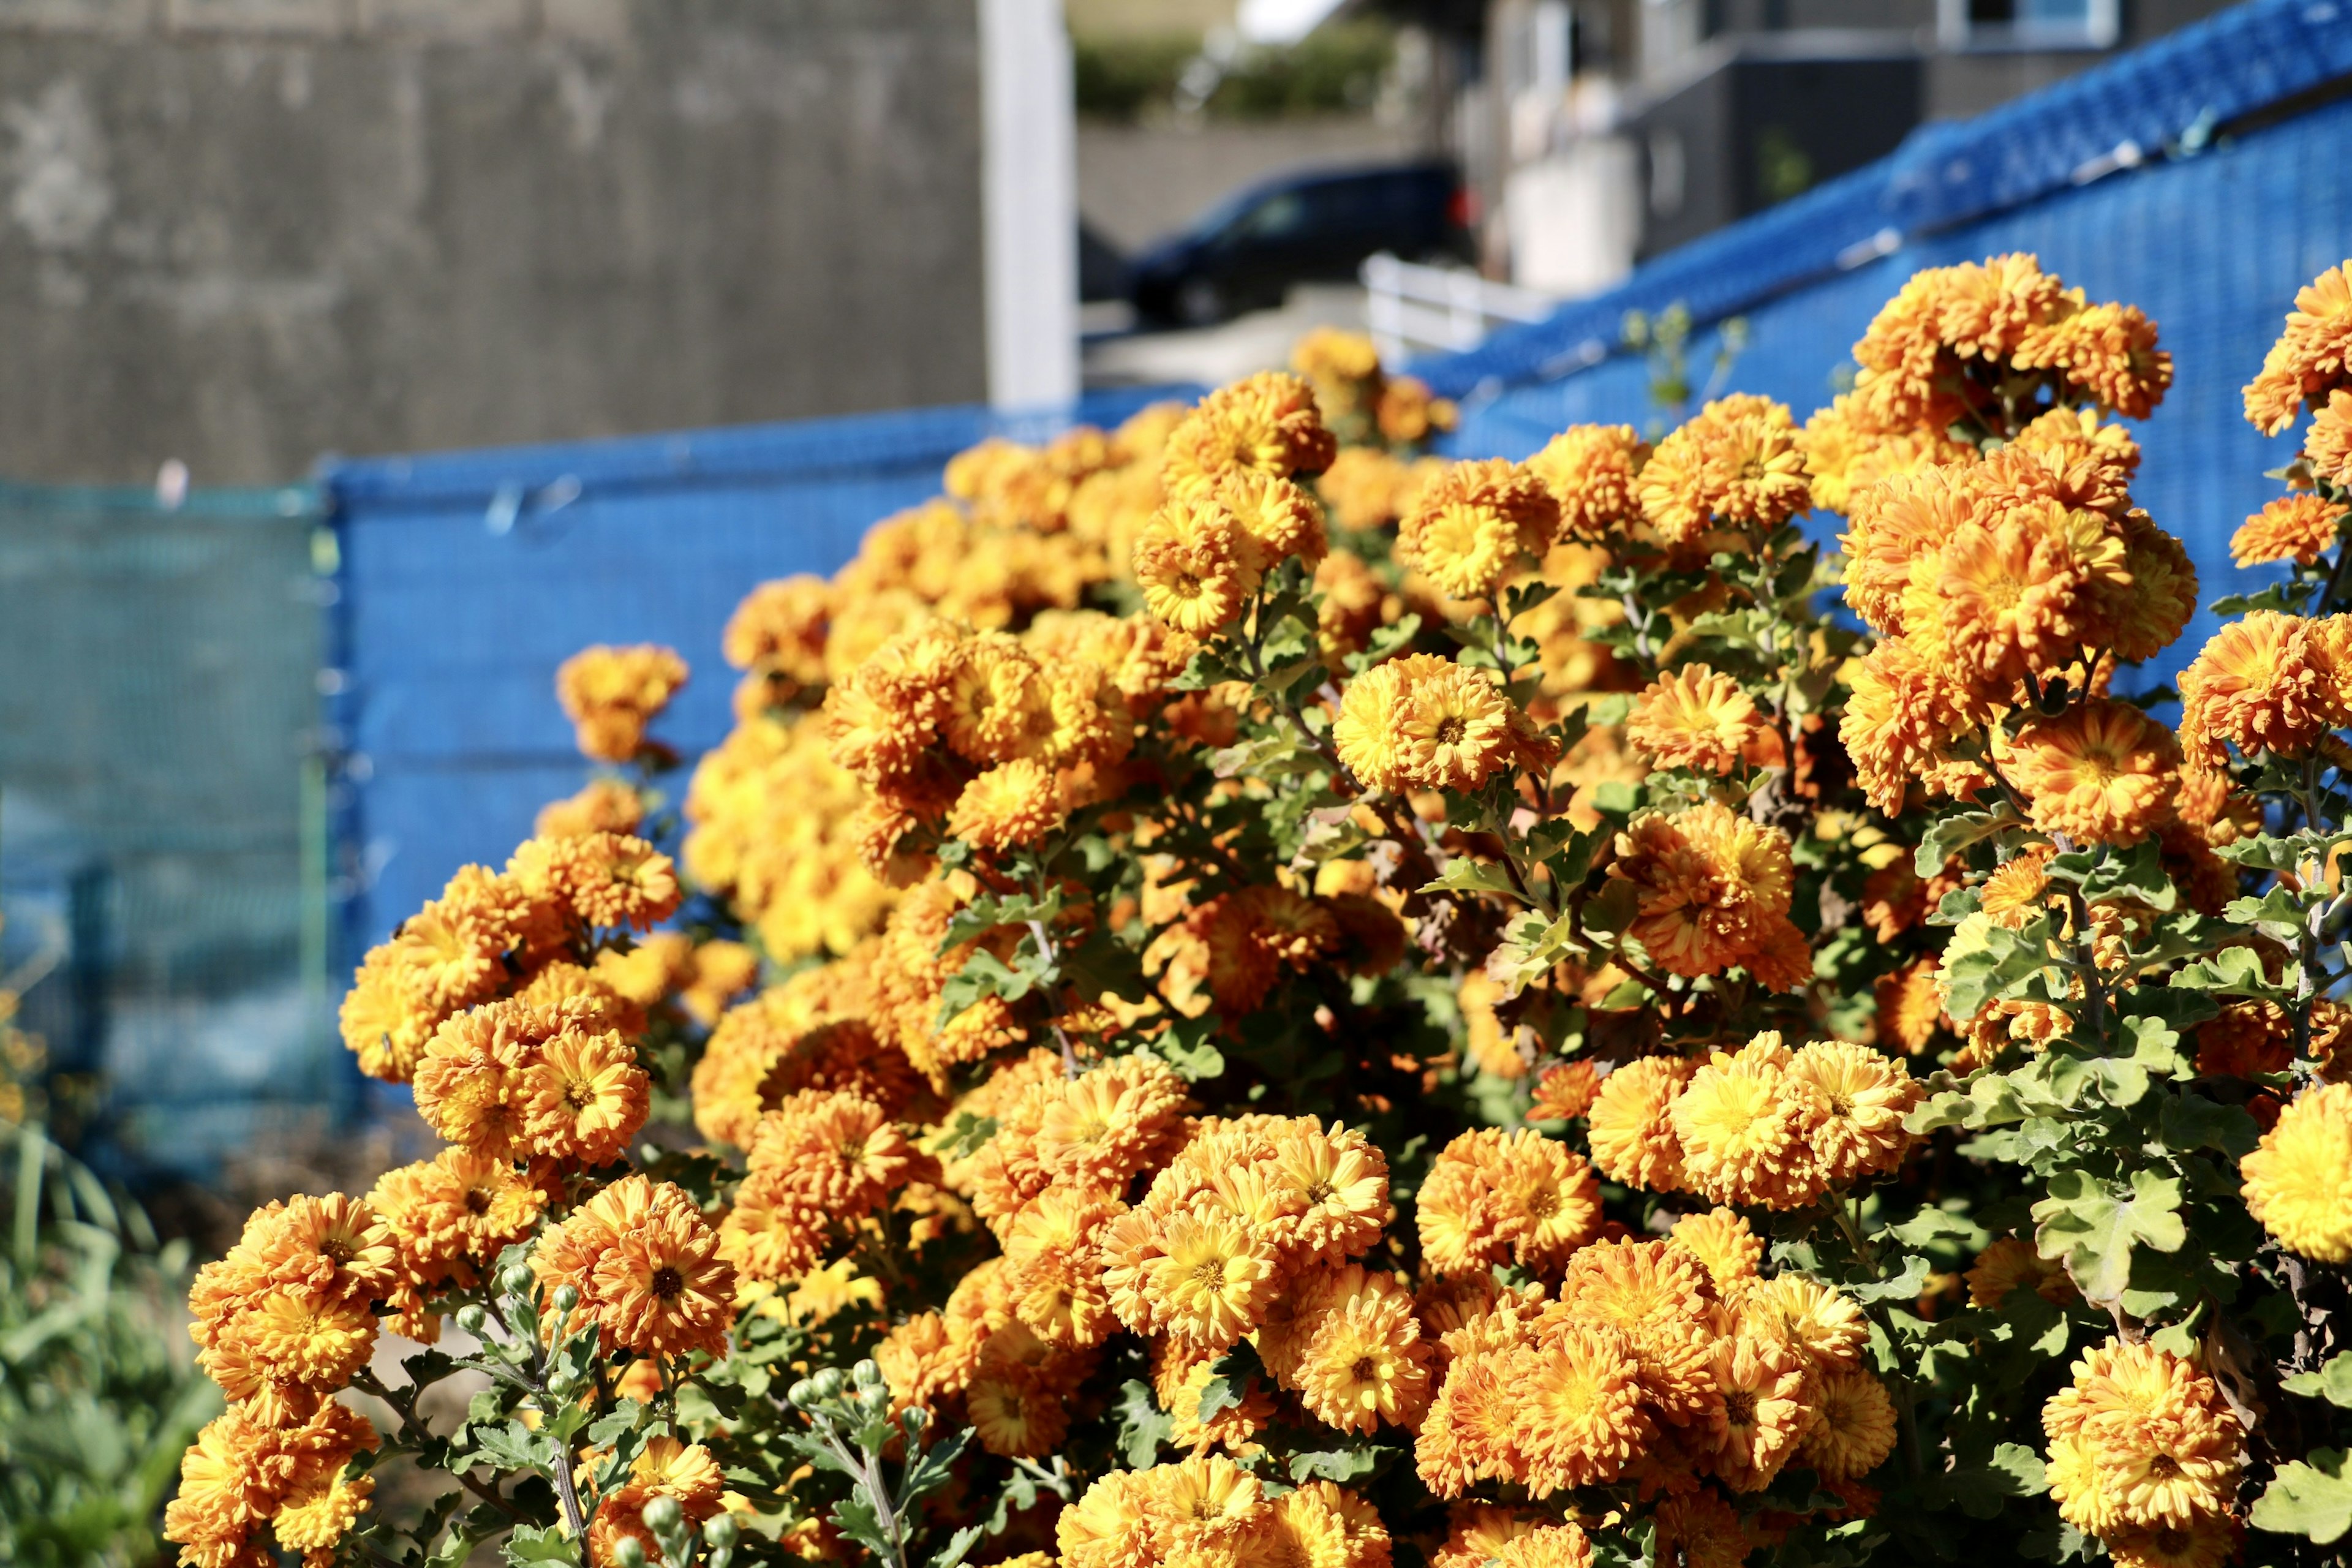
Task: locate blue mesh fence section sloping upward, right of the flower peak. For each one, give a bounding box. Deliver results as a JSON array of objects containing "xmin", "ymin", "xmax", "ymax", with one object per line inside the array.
[{"xmin": 1414, "ymin": 0, "xmax": 2352, "ymax": 679}]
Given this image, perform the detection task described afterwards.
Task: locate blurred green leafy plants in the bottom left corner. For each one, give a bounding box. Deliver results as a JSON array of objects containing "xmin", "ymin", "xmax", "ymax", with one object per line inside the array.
[{"xmin": 0, "ymin": 1124, "xmax": 221, "ymax": 1568}]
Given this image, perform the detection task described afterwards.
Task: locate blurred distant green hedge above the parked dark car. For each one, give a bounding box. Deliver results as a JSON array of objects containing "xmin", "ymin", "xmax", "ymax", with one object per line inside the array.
[{"xmin": 1072, "ymin": 21, "xmax": 1397, "ymax": 123}]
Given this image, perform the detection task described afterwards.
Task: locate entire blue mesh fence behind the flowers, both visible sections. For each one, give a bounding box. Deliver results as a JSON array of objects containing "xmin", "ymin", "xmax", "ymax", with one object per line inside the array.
[{"xmin": 322, "ymin": 0, "xmax": 2352, "ymax": 1090}]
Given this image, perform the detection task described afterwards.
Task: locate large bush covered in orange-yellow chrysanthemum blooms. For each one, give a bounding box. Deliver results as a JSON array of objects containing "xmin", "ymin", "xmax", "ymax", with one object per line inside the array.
[{"xmin": 169, "ymin": 256, "xmax": 2352, "ymax": 1568}]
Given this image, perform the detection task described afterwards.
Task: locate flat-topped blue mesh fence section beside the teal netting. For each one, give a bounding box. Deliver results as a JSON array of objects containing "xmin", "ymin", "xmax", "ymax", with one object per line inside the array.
[{"xmin": 325, "ymin": 388, "xmax": 1169, "ymax": 1030}]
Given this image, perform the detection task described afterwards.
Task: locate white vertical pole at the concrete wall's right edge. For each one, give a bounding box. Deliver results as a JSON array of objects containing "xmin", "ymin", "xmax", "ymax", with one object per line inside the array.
[{"xmin": 978, "ymin": 0, "xmax": 1080, "ymax": 409}]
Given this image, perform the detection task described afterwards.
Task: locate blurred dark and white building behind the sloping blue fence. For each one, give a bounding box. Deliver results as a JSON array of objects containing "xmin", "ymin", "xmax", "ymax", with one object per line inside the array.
[{"xmin": 1458, "ymin": 0, "xmax": 2220, "ymax": 296}]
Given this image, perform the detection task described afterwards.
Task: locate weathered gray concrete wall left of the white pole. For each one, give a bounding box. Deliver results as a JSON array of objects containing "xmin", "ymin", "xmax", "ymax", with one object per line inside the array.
[{"xmin": 0, "ymin": 0, "xmax": 986, "ymax": 484}]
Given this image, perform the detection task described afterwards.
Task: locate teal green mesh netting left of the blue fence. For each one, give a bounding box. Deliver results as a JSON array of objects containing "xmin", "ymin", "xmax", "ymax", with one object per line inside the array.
[{"xmin": 0, "ymin": 484, "xmax": 344, "ymax": 1175}]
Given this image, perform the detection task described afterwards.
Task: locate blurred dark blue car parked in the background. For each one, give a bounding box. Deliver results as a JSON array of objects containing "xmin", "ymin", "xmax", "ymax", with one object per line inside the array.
[{"xmin": 1131, "ymin": 162, "xmax": 1475, "ymax": 326}]
